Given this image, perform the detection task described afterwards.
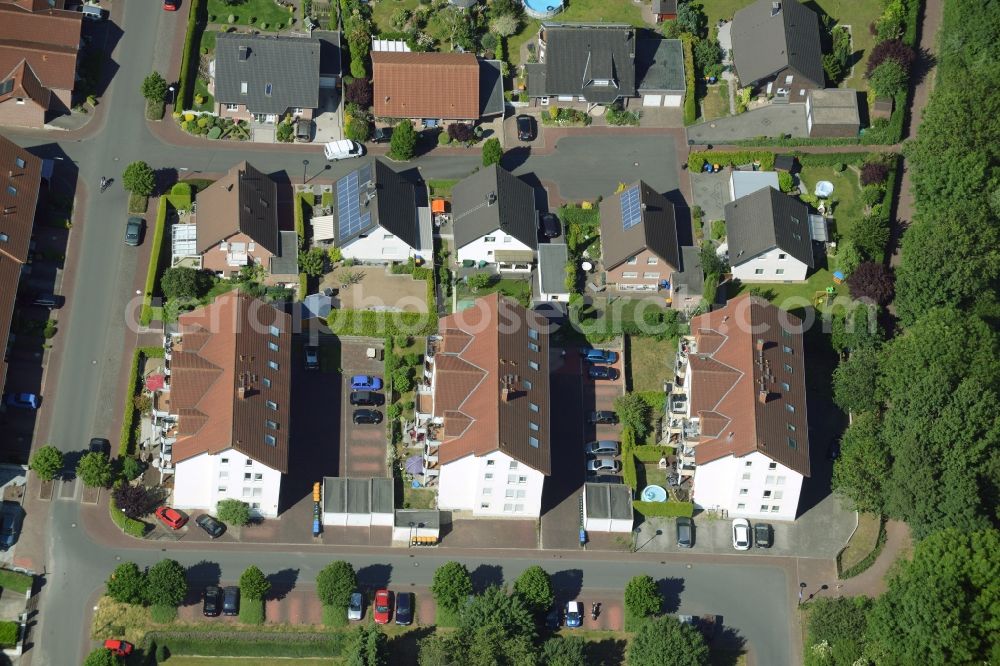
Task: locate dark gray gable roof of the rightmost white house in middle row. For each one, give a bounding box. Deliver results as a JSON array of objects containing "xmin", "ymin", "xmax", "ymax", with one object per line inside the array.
[{"xmin": 726, "ymin": 187, "xmax": 814, "ymax": 268}]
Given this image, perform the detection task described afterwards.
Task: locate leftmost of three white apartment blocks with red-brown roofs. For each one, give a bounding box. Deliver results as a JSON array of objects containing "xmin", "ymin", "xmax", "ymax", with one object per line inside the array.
[{"xmin": 168, "ymin": 291, "xmax": 292, "ymax": 517}]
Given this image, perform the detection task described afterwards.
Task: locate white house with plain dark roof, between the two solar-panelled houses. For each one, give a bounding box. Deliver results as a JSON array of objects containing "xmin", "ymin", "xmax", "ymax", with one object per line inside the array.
[{"xmin": 452, "ymin": 165, "xmax": 538, "ymax": 273}]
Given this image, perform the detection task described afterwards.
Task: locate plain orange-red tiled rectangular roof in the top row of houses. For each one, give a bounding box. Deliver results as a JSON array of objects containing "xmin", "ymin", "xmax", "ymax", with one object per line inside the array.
[{"xmin": 371, "ymin": 51, "xmax": 479, "ymax": 120}]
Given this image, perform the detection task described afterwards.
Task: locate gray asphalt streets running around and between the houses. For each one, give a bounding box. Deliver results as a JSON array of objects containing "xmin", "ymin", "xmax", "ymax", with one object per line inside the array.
[{"xmin": 1, "ymin": 2, "xmax": 792, "ymax": 665}]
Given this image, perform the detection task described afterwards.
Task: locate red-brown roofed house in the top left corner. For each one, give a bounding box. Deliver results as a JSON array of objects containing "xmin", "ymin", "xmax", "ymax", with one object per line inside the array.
[{"xmin": 0, "ymin": 0, "xmax": 83, "ymax": 127}]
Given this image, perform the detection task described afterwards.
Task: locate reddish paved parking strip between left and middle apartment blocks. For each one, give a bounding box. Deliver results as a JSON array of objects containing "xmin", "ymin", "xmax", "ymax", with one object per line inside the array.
[{"xmin": 340, "ymin": 339, "xmax": 387, "ymax": 477}]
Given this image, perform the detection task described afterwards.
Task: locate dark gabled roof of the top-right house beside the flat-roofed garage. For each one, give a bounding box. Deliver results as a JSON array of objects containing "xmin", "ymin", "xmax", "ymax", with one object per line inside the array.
[{"xmin": 732, "ymin": 0, "xmax": 825, "ymax": 86}]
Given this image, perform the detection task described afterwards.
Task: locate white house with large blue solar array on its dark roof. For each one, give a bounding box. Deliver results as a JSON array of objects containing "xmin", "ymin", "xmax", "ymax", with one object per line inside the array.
[{"xmin": 312, "ymin": 160, "xmax": 434, "ymax": 263}]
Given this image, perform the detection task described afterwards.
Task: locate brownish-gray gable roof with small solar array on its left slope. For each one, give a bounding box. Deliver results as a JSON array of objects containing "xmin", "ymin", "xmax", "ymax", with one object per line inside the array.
[{"xmin": 601, "ymin": 180, "xmax": 680, "ymax": 270}]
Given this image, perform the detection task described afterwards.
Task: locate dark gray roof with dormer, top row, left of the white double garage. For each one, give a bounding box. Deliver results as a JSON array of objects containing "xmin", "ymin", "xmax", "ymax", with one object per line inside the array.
[{"xmin": 542, "ymin": 24, "xmax": 636, "ymax": 104}]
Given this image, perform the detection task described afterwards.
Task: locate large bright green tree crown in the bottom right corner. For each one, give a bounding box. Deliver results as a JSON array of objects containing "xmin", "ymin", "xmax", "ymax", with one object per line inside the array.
[{"xmin": 865, "ymin": 528, "xmax": 1000, "ymax": 666}]
